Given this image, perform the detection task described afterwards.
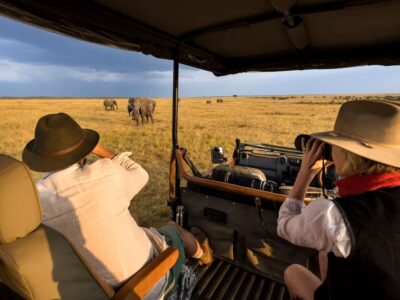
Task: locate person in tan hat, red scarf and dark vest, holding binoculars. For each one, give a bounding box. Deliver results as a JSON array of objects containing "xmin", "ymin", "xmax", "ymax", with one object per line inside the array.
[{"xmin": 278, "ymin": 100, "xmax": 400, "ymax": 299}]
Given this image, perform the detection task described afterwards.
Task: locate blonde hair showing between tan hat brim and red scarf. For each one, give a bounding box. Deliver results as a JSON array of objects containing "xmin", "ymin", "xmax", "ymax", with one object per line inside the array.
[{"xmin": 337, "ymin": 147, "xmax": 400, "ymax": 177}]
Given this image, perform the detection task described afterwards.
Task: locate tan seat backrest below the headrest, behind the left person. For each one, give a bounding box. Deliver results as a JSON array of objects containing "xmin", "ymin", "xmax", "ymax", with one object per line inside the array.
[{"xmin": 0, "ymin": 226, "xmax": 109, "ymax": 300}]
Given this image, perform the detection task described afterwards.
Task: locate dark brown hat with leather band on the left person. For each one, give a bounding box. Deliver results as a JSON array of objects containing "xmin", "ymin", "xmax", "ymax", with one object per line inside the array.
[{"xmin": 22, "ymin": 113, "xmax": 99, "ymax": 172}]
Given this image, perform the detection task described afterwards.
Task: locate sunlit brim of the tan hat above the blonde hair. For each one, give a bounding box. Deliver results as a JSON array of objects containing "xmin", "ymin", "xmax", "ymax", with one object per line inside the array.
[{"xmin": 311, "ymin": 131, "xmax": 400, "ymax": 168}]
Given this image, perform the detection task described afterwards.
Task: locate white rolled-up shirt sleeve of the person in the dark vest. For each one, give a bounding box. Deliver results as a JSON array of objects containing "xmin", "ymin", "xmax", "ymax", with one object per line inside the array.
[{"xmin": 278, "ymin": 197, "xmax": 351, "ymax": 257}]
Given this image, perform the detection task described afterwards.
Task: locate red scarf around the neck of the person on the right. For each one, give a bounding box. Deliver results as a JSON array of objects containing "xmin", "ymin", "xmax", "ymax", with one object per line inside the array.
[{"xmin": 335, "ymin": 171, "xmax": 400, "ymax": 197}]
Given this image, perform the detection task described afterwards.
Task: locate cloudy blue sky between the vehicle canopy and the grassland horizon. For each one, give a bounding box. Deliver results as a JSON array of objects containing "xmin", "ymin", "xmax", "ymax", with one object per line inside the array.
[{"xmin": 0, "ymin": 17, "xmax": 400, "ymax": 97}]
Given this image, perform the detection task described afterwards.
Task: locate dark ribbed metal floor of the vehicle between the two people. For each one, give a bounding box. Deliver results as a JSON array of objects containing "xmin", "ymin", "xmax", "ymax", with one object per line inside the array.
[{"xmin": 191, "ymin": 259, "xmax": 290, "ymax": 300}]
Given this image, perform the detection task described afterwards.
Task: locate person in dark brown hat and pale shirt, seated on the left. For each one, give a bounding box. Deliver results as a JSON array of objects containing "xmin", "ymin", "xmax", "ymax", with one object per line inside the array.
[{"xmin": 22, "ymin": 113, "xmax": 212, "ymax": 299}]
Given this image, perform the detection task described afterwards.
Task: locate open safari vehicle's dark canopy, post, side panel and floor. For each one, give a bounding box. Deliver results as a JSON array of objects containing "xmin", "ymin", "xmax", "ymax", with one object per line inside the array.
[{"xmin": 0, "ymin": 0, "xmax": 400, "ymax": 299}]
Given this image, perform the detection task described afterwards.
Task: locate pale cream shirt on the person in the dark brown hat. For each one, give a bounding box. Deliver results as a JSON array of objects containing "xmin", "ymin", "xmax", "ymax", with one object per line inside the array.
[{"xmin": 37, "ymin": 152, "xmax": 157, "ymax": 287}]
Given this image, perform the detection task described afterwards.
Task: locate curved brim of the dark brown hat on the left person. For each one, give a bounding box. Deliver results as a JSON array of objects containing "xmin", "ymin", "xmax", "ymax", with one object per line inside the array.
[{"xmin": 22, "ymin": 129, "xmax": 100, "ymax": 172}]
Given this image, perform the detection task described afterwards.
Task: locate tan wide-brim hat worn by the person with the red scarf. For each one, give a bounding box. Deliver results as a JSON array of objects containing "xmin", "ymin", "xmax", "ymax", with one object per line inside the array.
[{"xmin": 311, "ymin": 100, "xmax": 400, "ymax": 168}]
